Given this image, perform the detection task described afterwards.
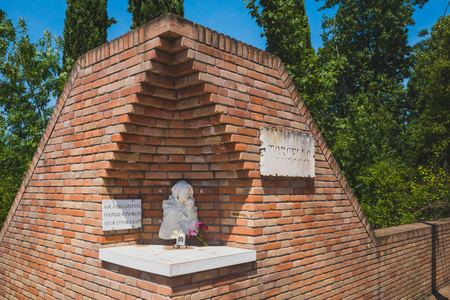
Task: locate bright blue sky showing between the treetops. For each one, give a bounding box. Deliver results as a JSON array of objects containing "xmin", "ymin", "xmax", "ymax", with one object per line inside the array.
[{"xmin": 0, "ymin": 0, "xmax": 450, "ymax": 49}]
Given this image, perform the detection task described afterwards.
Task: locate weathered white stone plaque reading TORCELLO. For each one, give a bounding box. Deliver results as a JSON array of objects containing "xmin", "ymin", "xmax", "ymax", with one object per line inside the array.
[{"xmin": 260, "ymin": 126, "xmax": 315, "ymax": 177}]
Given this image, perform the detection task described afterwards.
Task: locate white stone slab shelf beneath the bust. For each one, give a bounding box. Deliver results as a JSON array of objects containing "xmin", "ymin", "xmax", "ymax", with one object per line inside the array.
[{"xmin": 100, "ymin": 245, "xmax": 256, "ymax": 277}]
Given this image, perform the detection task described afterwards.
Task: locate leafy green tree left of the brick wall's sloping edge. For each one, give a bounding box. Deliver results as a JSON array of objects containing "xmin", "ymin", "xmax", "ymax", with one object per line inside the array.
[{"xmin": 0, "ymin": 10, "xmax": 66, "ymax": 224}]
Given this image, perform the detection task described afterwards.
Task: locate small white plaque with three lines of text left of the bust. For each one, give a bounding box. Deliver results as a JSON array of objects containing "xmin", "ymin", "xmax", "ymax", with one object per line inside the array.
[{"xmin": 102, "ymin": 199, "xmax": 142, "ymax": 231}]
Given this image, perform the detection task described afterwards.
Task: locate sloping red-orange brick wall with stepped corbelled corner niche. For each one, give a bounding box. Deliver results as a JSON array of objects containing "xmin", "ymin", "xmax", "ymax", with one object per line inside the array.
[{"xmin": 0, "ymin": 14, "xmax": 450, "ymax": 299}]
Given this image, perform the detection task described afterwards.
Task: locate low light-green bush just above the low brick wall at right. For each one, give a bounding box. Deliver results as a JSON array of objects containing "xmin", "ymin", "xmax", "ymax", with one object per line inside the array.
[{"xmin": 358, "ymin": 162, "xmax": 450, "ymax": 228}]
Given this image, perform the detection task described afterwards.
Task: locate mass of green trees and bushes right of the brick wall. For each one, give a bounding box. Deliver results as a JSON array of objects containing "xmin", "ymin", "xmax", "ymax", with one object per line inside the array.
[{"xmin": 245, "ymin": 0, "xmax": 450, "ymax": 228}]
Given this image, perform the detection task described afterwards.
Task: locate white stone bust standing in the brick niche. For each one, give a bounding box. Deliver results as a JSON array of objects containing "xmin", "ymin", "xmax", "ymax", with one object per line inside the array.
[{"xmin": 159, "ymin": 181, "xmax": 198, "ymax": 240}]
